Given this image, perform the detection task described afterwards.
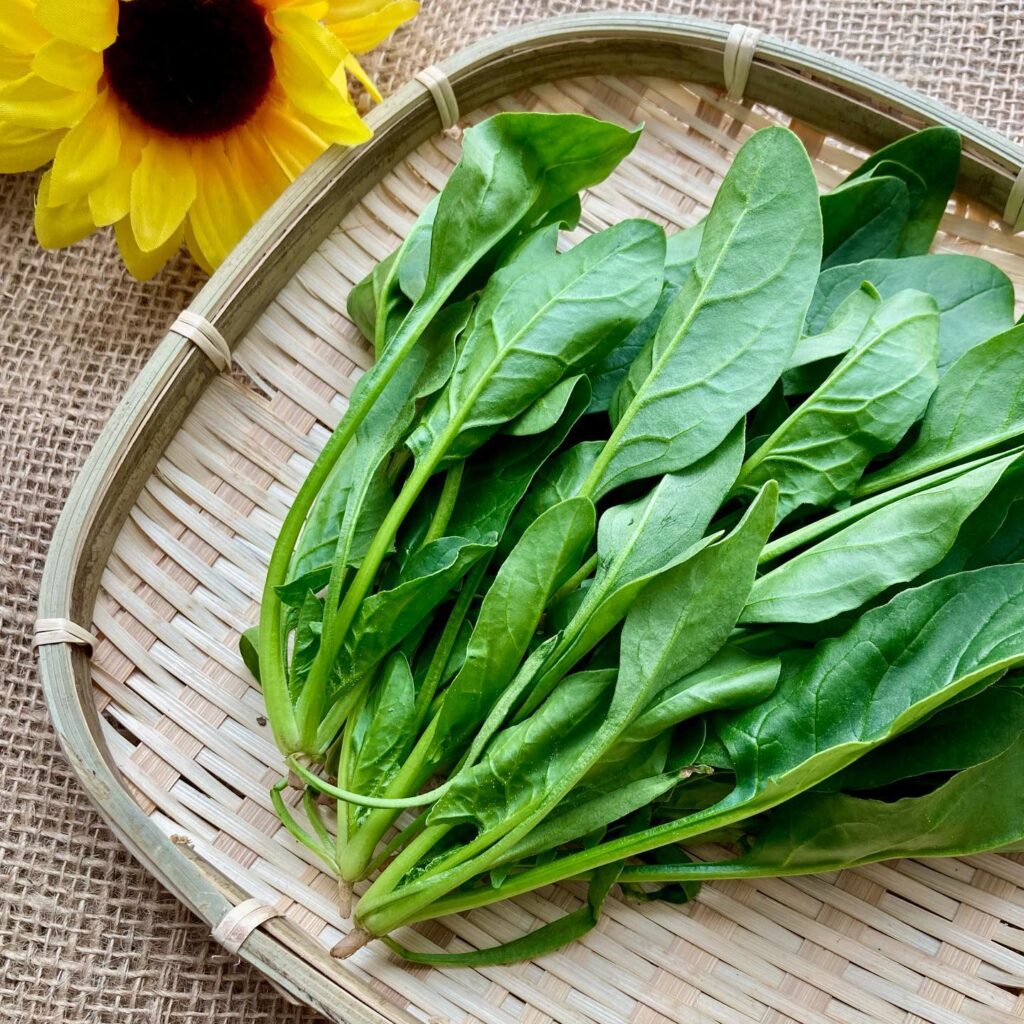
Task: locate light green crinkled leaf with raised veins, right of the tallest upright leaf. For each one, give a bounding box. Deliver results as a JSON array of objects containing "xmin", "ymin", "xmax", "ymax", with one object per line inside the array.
[{"xmin": 735, "ymin": 291, "xmax": 938, "ymax": 519}]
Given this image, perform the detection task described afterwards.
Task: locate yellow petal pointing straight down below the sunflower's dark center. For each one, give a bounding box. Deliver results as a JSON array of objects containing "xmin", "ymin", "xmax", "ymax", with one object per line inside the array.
[{"xmin": 131, "ymin": 135, "xmax": 196, "ymax": 252}]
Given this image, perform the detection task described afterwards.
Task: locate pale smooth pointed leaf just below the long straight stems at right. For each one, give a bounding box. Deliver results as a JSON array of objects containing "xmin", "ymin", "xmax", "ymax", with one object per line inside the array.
[{"xmin": 740, "ymin": 456, "xmax": 1020, "ymax": 623}]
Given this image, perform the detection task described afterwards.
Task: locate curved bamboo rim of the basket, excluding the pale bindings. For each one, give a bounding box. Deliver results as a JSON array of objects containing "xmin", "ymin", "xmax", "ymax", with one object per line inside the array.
[{"xmin": 37, "ymin": 13, "xmax": 1024, "ymax": 1022}]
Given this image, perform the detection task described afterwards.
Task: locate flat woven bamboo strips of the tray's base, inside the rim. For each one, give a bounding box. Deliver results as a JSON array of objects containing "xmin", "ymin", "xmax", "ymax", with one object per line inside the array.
[{"xmin": 81, "ymin": 77, "xmax": 1024, "ymax": 1024}]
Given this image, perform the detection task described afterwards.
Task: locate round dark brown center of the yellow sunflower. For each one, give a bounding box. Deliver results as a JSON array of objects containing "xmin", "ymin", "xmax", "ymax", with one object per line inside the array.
[{"xmin": 103, "ymin": 0, "xmax": 273, "ymax": 138}]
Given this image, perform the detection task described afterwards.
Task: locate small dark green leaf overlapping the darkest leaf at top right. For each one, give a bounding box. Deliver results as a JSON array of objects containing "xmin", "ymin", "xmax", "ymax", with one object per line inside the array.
[{"xmin": 821, "ymin": 176, "xmax": 910, "ymax": 269}]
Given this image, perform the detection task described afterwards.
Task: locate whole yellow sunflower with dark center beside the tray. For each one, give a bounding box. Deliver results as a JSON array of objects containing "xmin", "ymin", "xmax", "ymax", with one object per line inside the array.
[{"xmin": 0, "ymin": 0, "xmax": 419, "ymax": 279}]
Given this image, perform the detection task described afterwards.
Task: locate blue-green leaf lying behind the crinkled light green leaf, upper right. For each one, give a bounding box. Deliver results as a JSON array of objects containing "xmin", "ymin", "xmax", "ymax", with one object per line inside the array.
[{"xmin": 804, "ymin": 253, "xmax": 1014, "ymax": 373}]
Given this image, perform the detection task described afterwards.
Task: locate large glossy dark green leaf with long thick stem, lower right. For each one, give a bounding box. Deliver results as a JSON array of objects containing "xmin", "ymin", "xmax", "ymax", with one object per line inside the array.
[{"xmin": 481, "ymin": 565, "xmax": 1024, "ymax": 894}]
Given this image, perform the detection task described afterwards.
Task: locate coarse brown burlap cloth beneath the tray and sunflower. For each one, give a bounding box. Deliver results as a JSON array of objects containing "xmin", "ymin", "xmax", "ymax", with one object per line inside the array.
[{"xmin": 0, "ymin": 0, "xmax": 1024, "ymax": 1024}]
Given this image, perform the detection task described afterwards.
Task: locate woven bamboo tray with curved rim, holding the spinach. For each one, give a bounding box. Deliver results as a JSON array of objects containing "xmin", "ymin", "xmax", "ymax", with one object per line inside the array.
[{"xmin": 39, "ymin": 15, "xmax": 1024, "ymax": 1024}]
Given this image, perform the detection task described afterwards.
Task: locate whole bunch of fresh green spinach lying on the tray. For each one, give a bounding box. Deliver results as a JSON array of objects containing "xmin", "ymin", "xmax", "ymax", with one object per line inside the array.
[{"xmin": 242, "ymin": 114, "xmax": 1024, "ymax": 965}]
